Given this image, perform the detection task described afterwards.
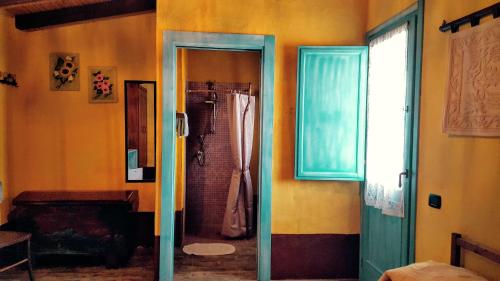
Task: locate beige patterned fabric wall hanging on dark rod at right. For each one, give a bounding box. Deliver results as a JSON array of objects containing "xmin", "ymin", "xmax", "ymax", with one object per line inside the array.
[{"xmin": 443, "ymin": 19, "xmax": 500, "ymax": 137}]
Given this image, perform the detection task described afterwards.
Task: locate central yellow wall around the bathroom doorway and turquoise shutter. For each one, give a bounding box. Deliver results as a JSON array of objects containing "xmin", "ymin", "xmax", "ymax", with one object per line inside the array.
[{"xmin": 156, "ymin": 0, "xmax": 366, "ymax": 234}]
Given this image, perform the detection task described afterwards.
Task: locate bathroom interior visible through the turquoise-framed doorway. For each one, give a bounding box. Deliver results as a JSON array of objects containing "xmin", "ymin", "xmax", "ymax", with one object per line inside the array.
[{"xmin": 174, "ymin": 49, "xmax": 261, "ymax": 279}]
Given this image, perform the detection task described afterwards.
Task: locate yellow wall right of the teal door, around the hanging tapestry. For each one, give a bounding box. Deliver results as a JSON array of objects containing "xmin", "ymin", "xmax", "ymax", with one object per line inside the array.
[{"xmin": 367, "ymin": 0, "xmax": 500, "ymax": 280}]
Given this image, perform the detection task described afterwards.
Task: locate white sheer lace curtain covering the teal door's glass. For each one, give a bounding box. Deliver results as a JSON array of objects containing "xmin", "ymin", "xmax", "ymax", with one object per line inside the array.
[{"xmin": 365, "ymin": 24, "xmax": 408, "ymax": 217}]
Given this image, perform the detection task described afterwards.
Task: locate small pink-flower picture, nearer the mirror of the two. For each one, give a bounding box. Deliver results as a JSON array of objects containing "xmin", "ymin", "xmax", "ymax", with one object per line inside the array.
[{"xmin": 89, "ymin": 67, "xmax": 118, "ymax": 103}]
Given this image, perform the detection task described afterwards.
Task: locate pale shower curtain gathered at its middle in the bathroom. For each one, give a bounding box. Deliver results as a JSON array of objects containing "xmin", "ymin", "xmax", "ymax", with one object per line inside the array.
[{"xmin": 221, "ymin": 94, "xmax": 255, "ymax": 238}]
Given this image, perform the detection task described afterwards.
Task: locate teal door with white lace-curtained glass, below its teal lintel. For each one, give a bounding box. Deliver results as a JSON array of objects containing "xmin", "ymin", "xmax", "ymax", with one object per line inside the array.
[{"xmin": 360, "ymin": 14, "xmax": 418, "ymax": 281}]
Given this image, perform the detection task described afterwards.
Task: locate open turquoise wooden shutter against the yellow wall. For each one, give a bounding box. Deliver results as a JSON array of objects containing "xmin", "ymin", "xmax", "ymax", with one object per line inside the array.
[{"xmin": 295, "ymin": 46, "xmax": 368, "ymax": 181}]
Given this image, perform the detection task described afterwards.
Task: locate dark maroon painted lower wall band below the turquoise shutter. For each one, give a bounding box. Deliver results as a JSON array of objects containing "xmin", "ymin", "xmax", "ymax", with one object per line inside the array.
[{"xmin": 271, "ymin": 234, "xmax": 359, "ymax": 280}]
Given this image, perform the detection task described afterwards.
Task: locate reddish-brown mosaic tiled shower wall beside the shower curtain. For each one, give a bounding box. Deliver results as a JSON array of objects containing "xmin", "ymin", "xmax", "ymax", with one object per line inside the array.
[{"xmin": 185, "ymin": 82, "xmax": 254, "ymax": 237}]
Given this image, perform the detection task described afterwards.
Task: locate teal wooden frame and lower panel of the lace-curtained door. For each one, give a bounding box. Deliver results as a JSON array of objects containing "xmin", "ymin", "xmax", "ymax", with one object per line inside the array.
[{"xmin": 359, "ymin": 3, "xmax": 424, "ymax": 281}]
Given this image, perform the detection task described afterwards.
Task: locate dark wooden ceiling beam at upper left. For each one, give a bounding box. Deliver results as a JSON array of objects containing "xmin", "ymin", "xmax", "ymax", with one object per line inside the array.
[{"xmin": 12, "ymin": 0, "xmax": 156, "ymax": 30}]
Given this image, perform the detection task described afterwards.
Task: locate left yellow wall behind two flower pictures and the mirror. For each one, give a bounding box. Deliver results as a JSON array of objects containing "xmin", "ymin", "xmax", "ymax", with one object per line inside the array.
[{"xmin": 1, "ymin": 13, "xmax": 156, "ymax": 211}]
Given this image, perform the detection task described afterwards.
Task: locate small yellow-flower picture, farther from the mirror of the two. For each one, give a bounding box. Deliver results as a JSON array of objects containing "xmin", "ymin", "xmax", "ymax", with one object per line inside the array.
[{"xmin": 49, "ymin": 53, "xmax": 80, "ymax": 91}]
